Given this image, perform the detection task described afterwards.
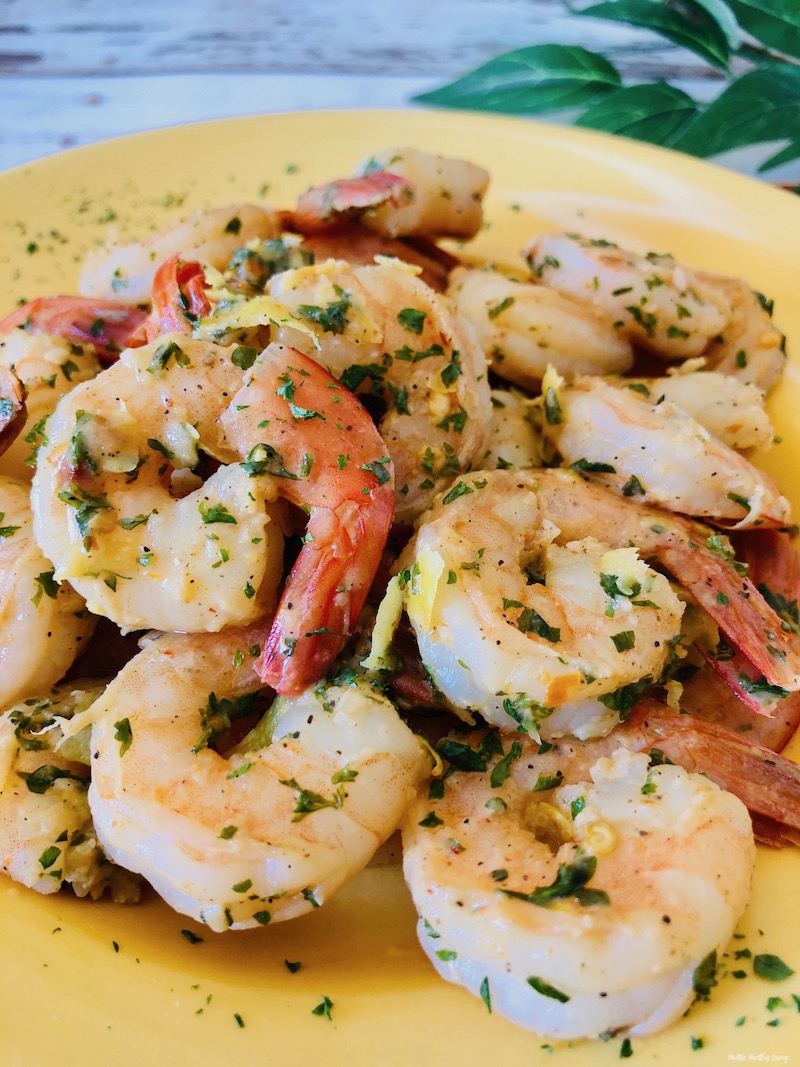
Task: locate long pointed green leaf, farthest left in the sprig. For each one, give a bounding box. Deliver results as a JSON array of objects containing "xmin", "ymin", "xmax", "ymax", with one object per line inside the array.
[{"xmin": 415, "ymin": 45, "xmax": 622, "ymax": 114}]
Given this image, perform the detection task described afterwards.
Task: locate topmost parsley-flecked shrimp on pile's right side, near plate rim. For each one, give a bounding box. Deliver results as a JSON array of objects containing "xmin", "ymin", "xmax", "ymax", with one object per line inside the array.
[{"xmin": 525, "ymin": 234, "xmax": 732, "ymax": 360}]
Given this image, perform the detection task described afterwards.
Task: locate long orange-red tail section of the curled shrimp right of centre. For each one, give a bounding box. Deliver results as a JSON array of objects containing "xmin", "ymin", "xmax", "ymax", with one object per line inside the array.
[{"xmin": 535, "ymin": 469, "xmax": 800, "ymax": 691}]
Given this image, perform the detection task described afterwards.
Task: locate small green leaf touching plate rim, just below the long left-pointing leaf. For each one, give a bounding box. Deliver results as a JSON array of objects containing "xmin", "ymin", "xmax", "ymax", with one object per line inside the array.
[{"xmin": 575, "ymin": 81, "xmax": 698, "ymax": 145}]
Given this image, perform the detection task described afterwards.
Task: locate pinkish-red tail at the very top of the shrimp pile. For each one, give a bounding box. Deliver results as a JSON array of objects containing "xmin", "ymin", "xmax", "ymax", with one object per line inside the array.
[{"xmin": 291, "ymin": 171, "xmax": 414, "ymax": 234}]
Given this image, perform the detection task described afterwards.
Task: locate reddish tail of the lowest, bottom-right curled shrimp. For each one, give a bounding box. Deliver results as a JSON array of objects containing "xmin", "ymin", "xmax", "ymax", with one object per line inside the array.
[{"xmin": 627, "ymin": 698, "xmax": 800, "ymax": 846}]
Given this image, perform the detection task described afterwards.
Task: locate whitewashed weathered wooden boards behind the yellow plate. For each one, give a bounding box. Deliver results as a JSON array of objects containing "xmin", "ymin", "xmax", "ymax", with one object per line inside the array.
[{"xmin": 0, "ymin": 0, "xmax": 768, "ymax": 170}]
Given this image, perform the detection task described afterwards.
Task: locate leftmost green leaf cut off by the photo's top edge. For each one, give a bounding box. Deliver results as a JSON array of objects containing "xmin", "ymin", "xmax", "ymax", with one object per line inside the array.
[{"xmin": 577, "ymin": 0, "xmax": 731, "ymax": 70}]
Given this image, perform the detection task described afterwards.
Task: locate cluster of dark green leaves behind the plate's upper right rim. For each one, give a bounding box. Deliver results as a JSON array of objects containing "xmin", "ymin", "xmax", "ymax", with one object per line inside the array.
[{"xmin": 417, "ymin": 0, "xmax": 800, "ymax": 171}]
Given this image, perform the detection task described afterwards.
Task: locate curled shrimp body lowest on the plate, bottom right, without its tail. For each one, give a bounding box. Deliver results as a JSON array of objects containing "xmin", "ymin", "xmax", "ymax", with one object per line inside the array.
[{"xmin": 403, "ymin": 736, "xmax": 755, "ymax": 1039}]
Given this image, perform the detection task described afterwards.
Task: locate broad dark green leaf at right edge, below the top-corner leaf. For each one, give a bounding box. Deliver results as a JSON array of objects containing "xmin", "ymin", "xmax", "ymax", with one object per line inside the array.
[{"xmin": 672, "ymin": 67, "xmax": 800, "ymax": 158}]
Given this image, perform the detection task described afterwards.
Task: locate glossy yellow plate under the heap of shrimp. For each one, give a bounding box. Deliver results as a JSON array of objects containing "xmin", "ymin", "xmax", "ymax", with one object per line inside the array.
[{"xmin": 0, "ymin": 111, "xmax": 800, "ymax": 1067}]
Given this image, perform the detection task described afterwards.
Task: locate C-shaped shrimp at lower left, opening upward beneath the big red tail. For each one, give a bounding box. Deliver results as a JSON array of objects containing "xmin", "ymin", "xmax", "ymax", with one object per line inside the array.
[{"xmin": 89, "ymin": 626, "xmax": 431, "ymax": 930}]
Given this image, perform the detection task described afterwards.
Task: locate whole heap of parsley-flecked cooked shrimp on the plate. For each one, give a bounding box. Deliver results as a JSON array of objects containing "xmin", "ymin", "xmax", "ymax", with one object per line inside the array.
[{"xmin": 0, "ymin": 148, "xmax": 800, "ymax": 1039}]
